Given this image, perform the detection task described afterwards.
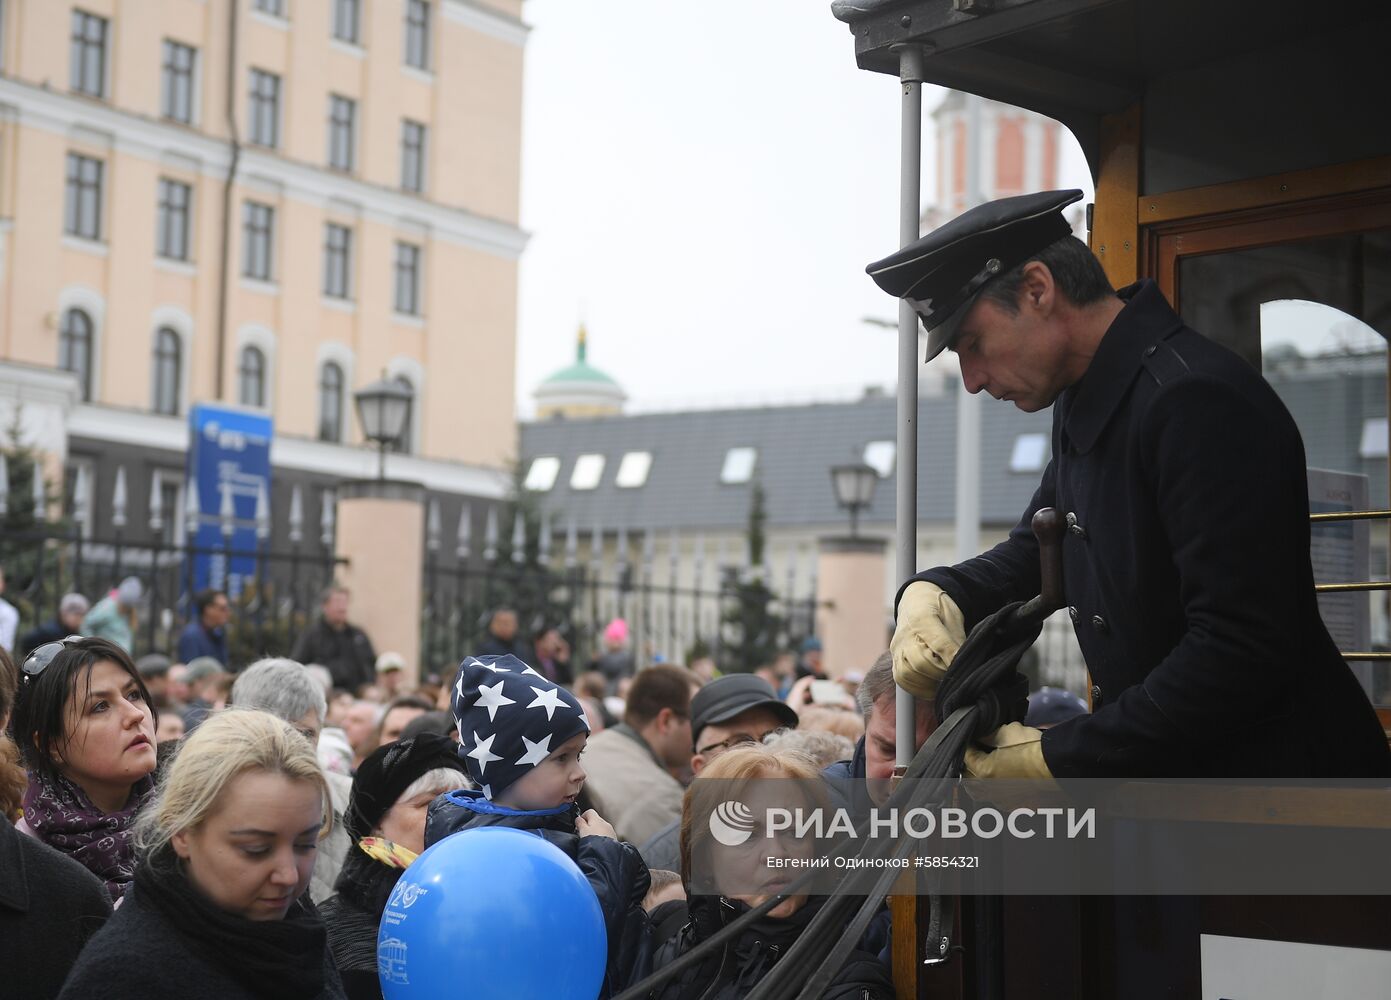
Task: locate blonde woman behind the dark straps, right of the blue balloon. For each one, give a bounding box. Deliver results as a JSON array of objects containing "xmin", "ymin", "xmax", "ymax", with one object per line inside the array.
[{"xmin": 652, "ymin": 745, "xmax": 893, "ymax": 1000}]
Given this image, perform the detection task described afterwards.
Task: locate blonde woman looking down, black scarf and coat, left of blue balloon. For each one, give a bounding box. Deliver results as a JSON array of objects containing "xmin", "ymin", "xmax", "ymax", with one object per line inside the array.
[{"xmin": 60, "ymin": 709, "xmax": 344, "ymax": 1000}]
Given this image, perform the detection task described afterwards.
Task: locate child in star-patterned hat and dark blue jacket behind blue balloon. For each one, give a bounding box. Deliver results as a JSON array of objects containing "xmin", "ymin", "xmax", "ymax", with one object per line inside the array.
[{"xmin": 426, "ymin": 655, "xmax": 650, "ymax": 997}]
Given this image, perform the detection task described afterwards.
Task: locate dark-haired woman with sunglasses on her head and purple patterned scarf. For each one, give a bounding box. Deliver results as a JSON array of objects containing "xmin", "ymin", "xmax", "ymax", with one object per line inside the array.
[{"xmin": 10, "ymin": 636, "xmax": 156, "ymax": 901}]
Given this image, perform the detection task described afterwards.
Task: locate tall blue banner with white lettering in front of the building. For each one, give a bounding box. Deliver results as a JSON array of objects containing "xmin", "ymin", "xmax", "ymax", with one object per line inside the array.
[{"xmin": 188, "ymin": 403, "xmax": 274, "ymax": 599}]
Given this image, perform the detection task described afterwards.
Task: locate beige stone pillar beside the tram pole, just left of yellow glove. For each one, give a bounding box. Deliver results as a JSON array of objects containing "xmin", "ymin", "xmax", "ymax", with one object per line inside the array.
[{"xmin": 817, "ymin": 537, "xmax": 890, "ymax": 677}]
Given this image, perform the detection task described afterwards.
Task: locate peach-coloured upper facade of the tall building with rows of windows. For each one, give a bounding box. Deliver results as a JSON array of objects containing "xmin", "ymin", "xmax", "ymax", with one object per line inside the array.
[{"xmin": 0, "ymin": 0, "xmax": 527, "ymax": 517}]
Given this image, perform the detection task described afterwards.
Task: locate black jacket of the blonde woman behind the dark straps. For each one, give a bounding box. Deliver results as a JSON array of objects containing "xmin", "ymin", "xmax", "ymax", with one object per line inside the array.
[{"xmin": 652, "ymin": 896, "xmax": 894, "ymax": 1000}]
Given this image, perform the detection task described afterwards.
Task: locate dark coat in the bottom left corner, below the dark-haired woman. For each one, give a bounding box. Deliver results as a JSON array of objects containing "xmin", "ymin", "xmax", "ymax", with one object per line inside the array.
[{"xmin": 0, "ymin": 816, "xmax": 111, "ymax": 1000}]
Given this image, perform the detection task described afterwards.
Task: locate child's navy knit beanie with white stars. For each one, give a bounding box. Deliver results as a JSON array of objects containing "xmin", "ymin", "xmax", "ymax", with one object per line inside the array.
[{"xmin": 452, "ymin": 655, "xmax": 590, "ymax": 800}]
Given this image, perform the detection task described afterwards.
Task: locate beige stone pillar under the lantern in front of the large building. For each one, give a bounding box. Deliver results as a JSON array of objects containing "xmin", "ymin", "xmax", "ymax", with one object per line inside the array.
[{"xmin": 338, "ymin": 480, "xmax": 426, "ymax": 683}]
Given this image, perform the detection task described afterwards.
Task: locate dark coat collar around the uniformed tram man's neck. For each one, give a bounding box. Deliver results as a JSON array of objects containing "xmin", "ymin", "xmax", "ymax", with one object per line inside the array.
[{"xmin": 1059, "ymin": 280, "xmax": 1184, "ymax": 455}]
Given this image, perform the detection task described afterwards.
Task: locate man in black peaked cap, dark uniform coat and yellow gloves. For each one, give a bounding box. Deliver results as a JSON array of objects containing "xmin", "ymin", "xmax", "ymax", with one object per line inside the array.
[{"xmin": 868, "ymin": 191, "xmax": 1391, "ymax": 777}]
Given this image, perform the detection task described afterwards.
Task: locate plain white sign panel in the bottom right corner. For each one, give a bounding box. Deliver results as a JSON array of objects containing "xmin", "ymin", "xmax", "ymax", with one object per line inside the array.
[{"xmin": 1200, "ymin": 935, "xmax": 1391, "ymax": 1000}]
